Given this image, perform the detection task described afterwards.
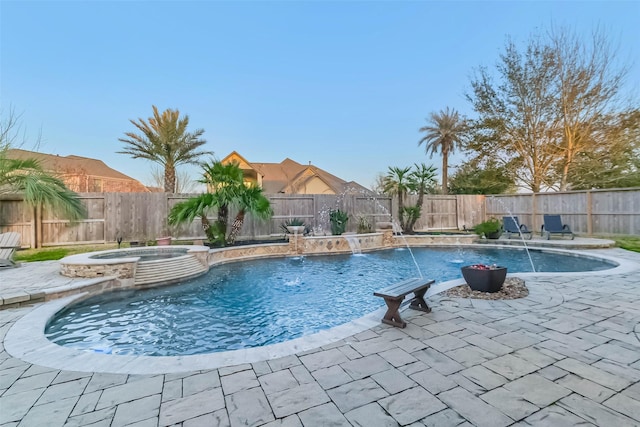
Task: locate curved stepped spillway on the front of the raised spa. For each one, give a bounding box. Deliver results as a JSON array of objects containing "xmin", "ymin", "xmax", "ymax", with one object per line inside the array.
[{"xmin": 134, "ymin": 255, "xmax": 207, "ymax": 285}]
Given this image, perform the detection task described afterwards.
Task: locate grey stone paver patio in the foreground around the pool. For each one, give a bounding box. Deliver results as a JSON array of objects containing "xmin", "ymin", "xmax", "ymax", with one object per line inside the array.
[{"xmin": 0, "ymin": 249, "xmax": 640, "ymax": 427}]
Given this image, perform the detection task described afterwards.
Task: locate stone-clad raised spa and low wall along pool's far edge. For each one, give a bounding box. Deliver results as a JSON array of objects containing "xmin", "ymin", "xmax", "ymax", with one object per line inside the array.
[{"xmin": 60, "ymin": 232, "xmax": 476, "ymax": 287}]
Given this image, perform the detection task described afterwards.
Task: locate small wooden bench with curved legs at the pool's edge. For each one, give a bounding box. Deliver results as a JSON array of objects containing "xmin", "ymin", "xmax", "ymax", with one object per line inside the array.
[{"xmin": 373, "ymin": 277, "xmax": 435, "ymax": 328}]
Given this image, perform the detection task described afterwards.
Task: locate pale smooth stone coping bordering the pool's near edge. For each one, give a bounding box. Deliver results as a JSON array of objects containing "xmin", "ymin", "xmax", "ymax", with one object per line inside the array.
[{"xmin": 4, "ymin": 245, "xmax": 638, "ymax": 374}]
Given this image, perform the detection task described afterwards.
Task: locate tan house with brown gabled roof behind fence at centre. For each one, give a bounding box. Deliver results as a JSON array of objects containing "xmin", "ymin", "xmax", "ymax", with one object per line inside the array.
[{"xmin": 221, "ymin": 151, "xmax": 372, "ymax": 194}]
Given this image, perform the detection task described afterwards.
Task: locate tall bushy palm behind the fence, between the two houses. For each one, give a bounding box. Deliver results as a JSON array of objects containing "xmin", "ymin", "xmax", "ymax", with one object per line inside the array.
[{"xmin": 118, "ymin": 105, "xmax": 213, "ymax": 193}]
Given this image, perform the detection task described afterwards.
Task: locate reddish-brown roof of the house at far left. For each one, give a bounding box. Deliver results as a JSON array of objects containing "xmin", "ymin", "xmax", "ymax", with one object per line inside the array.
[{"xmin": 7, "ymin": 148, "xmax": 142, "ymax": 185}]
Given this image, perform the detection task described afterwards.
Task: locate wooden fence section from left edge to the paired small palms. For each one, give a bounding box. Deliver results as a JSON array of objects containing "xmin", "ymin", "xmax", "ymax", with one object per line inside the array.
[{"xmin": 0, "ymin": 193, "xmax": 391, "ymax": 247}]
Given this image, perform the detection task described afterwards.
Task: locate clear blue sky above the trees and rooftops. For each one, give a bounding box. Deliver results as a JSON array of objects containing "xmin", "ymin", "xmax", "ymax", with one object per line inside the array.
[{"xmin": 0, "ymin": 0, "xmax": 640, "ymax": 191}]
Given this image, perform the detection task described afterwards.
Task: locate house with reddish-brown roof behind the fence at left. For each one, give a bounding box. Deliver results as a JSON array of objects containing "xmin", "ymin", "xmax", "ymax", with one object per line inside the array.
[{"xmin": 7, "ymin": 149, "xmax": 149, "ymax": 193}]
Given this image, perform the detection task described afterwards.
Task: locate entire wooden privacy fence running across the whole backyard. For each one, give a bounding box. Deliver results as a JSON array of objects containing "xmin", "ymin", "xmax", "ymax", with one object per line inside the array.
[{"xmin": 0, "ymin": 188, "xmax": 640, "ymax": 247}]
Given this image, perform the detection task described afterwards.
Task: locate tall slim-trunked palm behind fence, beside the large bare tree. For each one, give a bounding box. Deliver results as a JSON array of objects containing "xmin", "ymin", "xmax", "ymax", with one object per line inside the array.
[{"xmin": 418, "ymin": 107, "xmax": 466, "ymax": 194}]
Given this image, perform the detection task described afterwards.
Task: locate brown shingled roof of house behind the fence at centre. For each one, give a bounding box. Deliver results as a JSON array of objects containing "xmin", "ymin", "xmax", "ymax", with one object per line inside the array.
[{"xmin": 222, "ymin": 151, "xmax": 371, "ymax": 194}]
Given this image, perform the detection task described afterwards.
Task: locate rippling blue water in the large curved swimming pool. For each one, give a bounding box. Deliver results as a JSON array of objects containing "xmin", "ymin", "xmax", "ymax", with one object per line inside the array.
[{"xmin": 45, "ymin": 248, "xmax": 613, "ymax": 356}]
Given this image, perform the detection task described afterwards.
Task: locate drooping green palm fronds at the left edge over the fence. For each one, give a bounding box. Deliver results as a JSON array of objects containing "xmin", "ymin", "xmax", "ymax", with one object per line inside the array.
[{"xmin": 0, "ymin": 150, "xmax": 87, "ymax": 221}]
